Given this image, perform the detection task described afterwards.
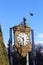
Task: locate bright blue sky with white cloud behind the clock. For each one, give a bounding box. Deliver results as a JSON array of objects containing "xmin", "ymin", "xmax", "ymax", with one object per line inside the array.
[{"xmin": 0, "ymin": 0, "xmax": 43, "ymax": 44}]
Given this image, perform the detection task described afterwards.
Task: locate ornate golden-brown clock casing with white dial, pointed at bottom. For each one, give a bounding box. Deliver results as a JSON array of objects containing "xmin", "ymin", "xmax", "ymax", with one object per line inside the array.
[{"xmin": 13, "ymin": 18, "xmax": 32, "ymax": 57}]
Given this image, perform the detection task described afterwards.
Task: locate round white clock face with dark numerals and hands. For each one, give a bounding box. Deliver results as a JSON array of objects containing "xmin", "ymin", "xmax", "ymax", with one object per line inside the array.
[{"xmin": 17, "ymin": 33, "xmax": 29, "ymax": 46}]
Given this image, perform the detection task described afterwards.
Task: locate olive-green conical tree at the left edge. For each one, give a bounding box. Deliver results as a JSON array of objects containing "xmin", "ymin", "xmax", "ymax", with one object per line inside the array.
[{"xmin": 0, "ymin": 26, "xmax": 10, "ymax": 65}]
